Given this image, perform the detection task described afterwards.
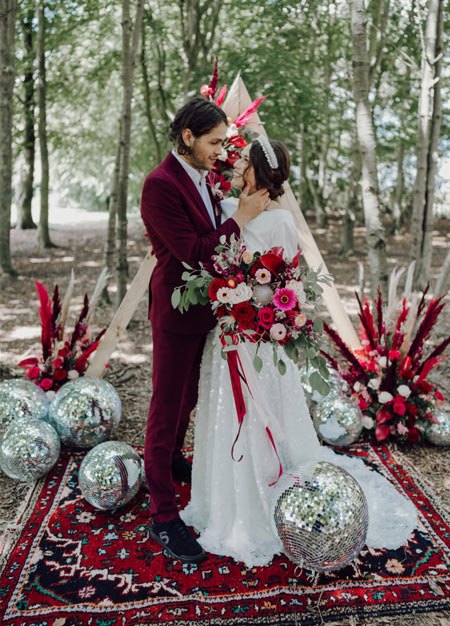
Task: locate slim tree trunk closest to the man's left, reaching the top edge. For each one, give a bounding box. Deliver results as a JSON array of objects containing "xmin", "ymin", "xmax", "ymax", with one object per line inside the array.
[{"xmin": 116, "ymin": 0, "xmax": 144, "ymax": 306}]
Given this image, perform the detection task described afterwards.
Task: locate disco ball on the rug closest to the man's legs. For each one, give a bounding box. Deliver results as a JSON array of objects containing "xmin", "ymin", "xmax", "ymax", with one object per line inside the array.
[{"xmin": 78, "ymin": 441, "xmax": 144, "ymax": 511}]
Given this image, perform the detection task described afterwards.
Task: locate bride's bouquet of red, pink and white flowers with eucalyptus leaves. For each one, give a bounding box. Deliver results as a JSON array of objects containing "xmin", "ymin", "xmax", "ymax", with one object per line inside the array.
[{"xmin": 172, "ymin": 235, "xmax": 330, "ymax": 395}]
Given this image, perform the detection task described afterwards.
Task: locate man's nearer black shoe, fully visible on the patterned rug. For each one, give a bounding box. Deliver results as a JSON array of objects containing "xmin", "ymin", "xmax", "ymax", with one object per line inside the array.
[{"xmin": 150, "ymin": 517, "xmax": 207, "ymax": 563}]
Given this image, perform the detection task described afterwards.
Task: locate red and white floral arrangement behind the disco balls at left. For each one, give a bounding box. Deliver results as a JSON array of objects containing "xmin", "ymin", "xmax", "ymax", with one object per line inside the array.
[{"xmin": 18, "ymin": 277, "xmax": 106, "ymax": 392}]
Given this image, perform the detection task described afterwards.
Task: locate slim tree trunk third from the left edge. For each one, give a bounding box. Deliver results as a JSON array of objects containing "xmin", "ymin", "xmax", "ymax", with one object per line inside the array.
[{"xmin": 37, "ymin": 0, "xmax": 53, "ymax": 248}]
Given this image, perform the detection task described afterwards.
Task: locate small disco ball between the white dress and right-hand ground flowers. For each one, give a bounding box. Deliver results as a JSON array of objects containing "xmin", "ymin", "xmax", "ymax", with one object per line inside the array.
[{"xmin": 313, "ymin": 392, "xmax": 363, "ymax": 446}]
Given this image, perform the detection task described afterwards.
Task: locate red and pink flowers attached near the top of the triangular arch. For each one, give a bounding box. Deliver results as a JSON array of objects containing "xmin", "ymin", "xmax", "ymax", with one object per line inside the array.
[{"xmin": 200, "ymin": 57, "xmax": 267, "ymax": 200}]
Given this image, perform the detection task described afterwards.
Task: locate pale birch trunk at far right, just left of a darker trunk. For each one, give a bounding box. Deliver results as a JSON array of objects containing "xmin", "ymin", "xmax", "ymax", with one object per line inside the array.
[{"xmin": 410, "ymin": 0, "xmax": 444, "ymax": 288}]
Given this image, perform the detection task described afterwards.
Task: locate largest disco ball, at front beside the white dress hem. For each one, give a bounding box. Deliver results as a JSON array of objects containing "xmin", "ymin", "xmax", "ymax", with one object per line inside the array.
[{"xmin": 273, "ymin": 461, "xmax": 369, "ymax": 572}]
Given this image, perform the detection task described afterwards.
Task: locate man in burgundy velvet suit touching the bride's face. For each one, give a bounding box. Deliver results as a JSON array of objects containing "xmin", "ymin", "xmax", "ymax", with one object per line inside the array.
[{"xmin": 141, "ymin": 98, "xmax": 270, "ymax": 562}]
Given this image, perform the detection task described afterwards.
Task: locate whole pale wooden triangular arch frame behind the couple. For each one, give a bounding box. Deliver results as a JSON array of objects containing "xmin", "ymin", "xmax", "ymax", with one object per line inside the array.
[{"xmin": 85, "ymin": 73, "xmax": 359, "ymax": 376}]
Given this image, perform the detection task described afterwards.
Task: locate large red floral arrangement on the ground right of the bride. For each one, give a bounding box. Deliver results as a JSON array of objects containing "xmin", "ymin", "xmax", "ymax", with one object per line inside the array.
[{"xmin": 323, "ymin": 287, "xmax": 450, "ymax": 442}]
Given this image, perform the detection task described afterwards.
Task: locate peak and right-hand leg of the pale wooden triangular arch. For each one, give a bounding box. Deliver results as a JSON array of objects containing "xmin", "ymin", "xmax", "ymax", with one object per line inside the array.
[{"xmin": 222, "ymin": 74, "xmax": 360, "ymax": 350}]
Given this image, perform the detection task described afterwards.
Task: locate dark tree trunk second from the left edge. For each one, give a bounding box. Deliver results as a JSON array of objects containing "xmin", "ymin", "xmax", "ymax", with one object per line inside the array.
[{"xmin": 16, "ymin": 8, "xmax": 36, "ymax": 230}]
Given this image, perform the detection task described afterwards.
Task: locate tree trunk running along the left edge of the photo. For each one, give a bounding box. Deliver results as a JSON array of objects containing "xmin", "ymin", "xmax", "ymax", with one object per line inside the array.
[{"xmin": 0, "ymin": 0, "xmax": 17, "ymax": 276}]
